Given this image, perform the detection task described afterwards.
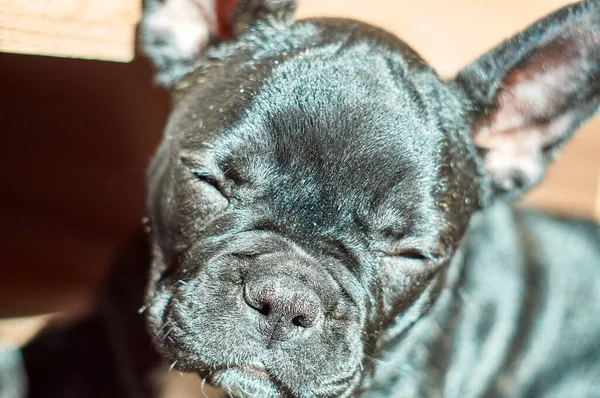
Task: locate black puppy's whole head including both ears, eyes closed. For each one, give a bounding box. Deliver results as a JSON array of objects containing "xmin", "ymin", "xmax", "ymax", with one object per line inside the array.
[{"xmin": 142, "ymin": 0, "xmax": 600, "ymax": 397}]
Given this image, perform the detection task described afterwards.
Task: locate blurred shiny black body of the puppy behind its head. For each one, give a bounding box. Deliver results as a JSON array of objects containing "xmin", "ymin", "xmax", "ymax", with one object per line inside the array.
[{"xmin": 365, "ymin": 205, "xmax": 600, "ymax": 397}]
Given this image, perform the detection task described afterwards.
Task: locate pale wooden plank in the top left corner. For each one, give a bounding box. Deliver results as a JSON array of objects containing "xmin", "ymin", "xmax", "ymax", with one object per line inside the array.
[{"xmin": 0, "ymin": 0, "xmax": 141, "ymax": 62}]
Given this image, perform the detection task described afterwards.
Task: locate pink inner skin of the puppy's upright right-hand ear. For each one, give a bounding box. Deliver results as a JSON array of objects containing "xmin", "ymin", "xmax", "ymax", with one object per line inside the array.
[{"xmin": 473, "ymin": 32, "xmax": 589, "ymax": 190}]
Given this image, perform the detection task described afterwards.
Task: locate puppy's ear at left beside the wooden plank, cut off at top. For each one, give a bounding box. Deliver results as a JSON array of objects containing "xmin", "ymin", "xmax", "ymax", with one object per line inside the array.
[{"xmin": 140, "ymin": 0, "xmax": 296, "ymax": 87}]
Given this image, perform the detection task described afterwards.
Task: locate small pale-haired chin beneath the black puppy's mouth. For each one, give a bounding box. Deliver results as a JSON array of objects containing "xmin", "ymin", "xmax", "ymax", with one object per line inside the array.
[{"xmin": 209, "ymin": 365, "xmax": 282, "ymax": 398}]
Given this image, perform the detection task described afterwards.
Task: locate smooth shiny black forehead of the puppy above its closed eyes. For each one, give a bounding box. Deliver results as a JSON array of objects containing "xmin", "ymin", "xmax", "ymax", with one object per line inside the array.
[{"xmin": 169, "ymin": 46, "xmax": 442, "ymax": 235}]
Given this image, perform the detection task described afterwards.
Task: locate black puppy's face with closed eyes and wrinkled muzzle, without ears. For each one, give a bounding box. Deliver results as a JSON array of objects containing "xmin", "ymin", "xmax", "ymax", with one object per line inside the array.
[{"xmin": 143, "ymin": 23, "xmax": 477, "ymax": 396}]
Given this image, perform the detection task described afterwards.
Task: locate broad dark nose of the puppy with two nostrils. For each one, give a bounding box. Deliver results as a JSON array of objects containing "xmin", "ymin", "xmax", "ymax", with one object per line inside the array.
[{"xmin": 244, "ymin": 276, "xmax": 323, "ymax": 341}]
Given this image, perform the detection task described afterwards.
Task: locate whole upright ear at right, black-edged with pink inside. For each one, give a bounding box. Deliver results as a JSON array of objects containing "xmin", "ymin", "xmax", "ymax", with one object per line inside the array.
[{"xmin": 455, "ymin": 0, "xmax": 600, "ymax": 197}]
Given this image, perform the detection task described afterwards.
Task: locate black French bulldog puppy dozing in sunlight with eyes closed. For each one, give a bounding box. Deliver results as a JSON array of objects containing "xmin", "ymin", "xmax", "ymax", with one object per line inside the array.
[{"xmin": 16, "ymin": 0, "xmax": 600, "ymax": 397}]
